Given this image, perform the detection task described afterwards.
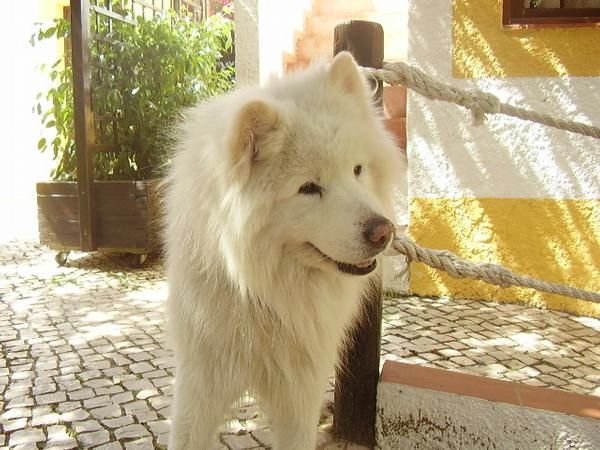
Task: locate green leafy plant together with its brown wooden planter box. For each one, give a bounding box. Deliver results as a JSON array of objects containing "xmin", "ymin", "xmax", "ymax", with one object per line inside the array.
[{"xmin": 32, "ymin": 0, "xmax": 233, "ymax": 264}]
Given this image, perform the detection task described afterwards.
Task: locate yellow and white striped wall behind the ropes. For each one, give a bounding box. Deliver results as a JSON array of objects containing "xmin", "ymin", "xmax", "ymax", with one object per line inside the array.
[{"xmin": 407, "ymin": 0, "xmax": 600, "ymax": 316}]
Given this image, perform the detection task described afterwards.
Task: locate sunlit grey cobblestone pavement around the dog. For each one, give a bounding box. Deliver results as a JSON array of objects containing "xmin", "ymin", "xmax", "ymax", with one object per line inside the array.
[{"xmin": 0, "ymin": 242, "xmax": 600, "ymax": 450}]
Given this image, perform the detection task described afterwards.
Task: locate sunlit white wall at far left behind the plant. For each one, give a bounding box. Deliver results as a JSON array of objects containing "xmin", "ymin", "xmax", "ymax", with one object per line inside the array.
[{"xmin": 0, "ymin": 0, "xmax": 56, "ymax": 242}]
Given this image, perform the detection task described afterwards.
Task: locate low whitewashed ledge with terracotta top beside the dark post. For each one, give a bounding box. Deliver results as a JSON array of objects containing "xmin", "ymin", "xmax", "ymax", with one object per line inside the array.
[{"xmin": 376, "ymin": 361, "xmax": 600, "ymax": 450}]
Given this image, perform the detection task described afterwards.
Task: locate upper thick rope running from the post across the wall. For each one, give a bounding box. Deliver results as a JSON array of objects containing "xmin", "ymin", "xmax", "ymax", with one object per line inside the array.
[{"xmin": 363, "ymin": 62, "xmax": 600, "ymax": 139}]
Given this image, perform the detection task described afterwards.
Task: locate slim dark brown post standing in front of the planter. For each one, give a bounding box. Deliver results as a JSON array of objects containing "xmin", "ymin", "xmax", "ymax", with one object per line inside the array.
[{"xmin": 71, "ymin": 0, "xmax": 96, "ymax": 251}]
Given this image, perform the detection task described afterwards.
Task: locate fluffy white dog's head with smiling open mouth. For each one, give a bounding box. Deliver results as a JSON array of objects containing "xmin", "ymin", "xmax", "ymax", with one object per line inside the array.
[{"xmin": 218, "ymin": 53, "xmax": 405, "ymax": 282}]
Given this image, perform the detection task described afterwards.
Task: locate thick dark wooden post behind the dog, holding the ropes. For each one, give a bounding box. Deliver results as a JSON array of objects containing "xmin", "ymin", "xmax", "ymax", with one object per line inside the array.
[{"xmin": 333, "ymin": 20, "xmax": 383, "ymax": 448}]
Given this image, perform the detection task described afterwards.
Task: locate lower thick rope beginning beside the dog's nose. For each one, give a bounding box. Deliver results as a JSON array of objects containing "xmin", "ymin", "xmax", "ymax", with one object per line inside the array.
[{"xmin": 392, "ymin": 236, "xmax": 600, "ymax": 303}]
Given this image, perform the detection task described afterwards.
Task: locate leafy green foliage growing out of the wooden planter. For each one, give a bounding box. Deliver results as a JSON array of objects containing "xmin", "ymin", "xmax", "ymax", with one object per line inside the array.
[{"xmin": 32, "ymin": 0, "xmax": 233, "ymax": 180}]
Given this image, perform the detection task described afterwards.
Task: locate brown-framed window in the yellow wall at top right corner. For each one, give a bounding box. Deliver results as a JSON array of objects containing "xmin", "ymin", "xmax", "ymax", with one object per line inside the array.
[{"xmin": 502, "ymin": 0, "xmax": 600, "ymax": 28}]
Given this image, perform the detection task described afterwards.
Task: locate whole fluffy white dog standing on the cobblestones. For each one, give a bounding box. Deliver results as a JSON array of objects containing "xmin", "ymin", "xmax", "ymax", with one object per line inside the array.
[{"xmin": 165, "ymin": 53, "xmax": 405, "ymax": 450}]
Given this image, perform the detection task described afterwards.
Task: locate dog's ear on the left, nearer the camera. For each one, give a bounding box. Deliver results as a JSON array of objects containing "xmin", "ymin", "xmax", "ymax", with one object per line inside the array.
[{"xmin": 230, "ymin": 100, "xmax": 280, "ymax": 165}]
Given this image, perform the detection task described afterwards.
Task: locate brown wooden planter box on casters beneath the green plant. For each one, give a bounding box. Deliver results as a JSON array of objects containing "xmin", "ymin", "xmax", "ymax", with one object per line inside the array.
[{"xmin": 37, "ymin": 180, "xmax": 159, "ymax": 262}]
